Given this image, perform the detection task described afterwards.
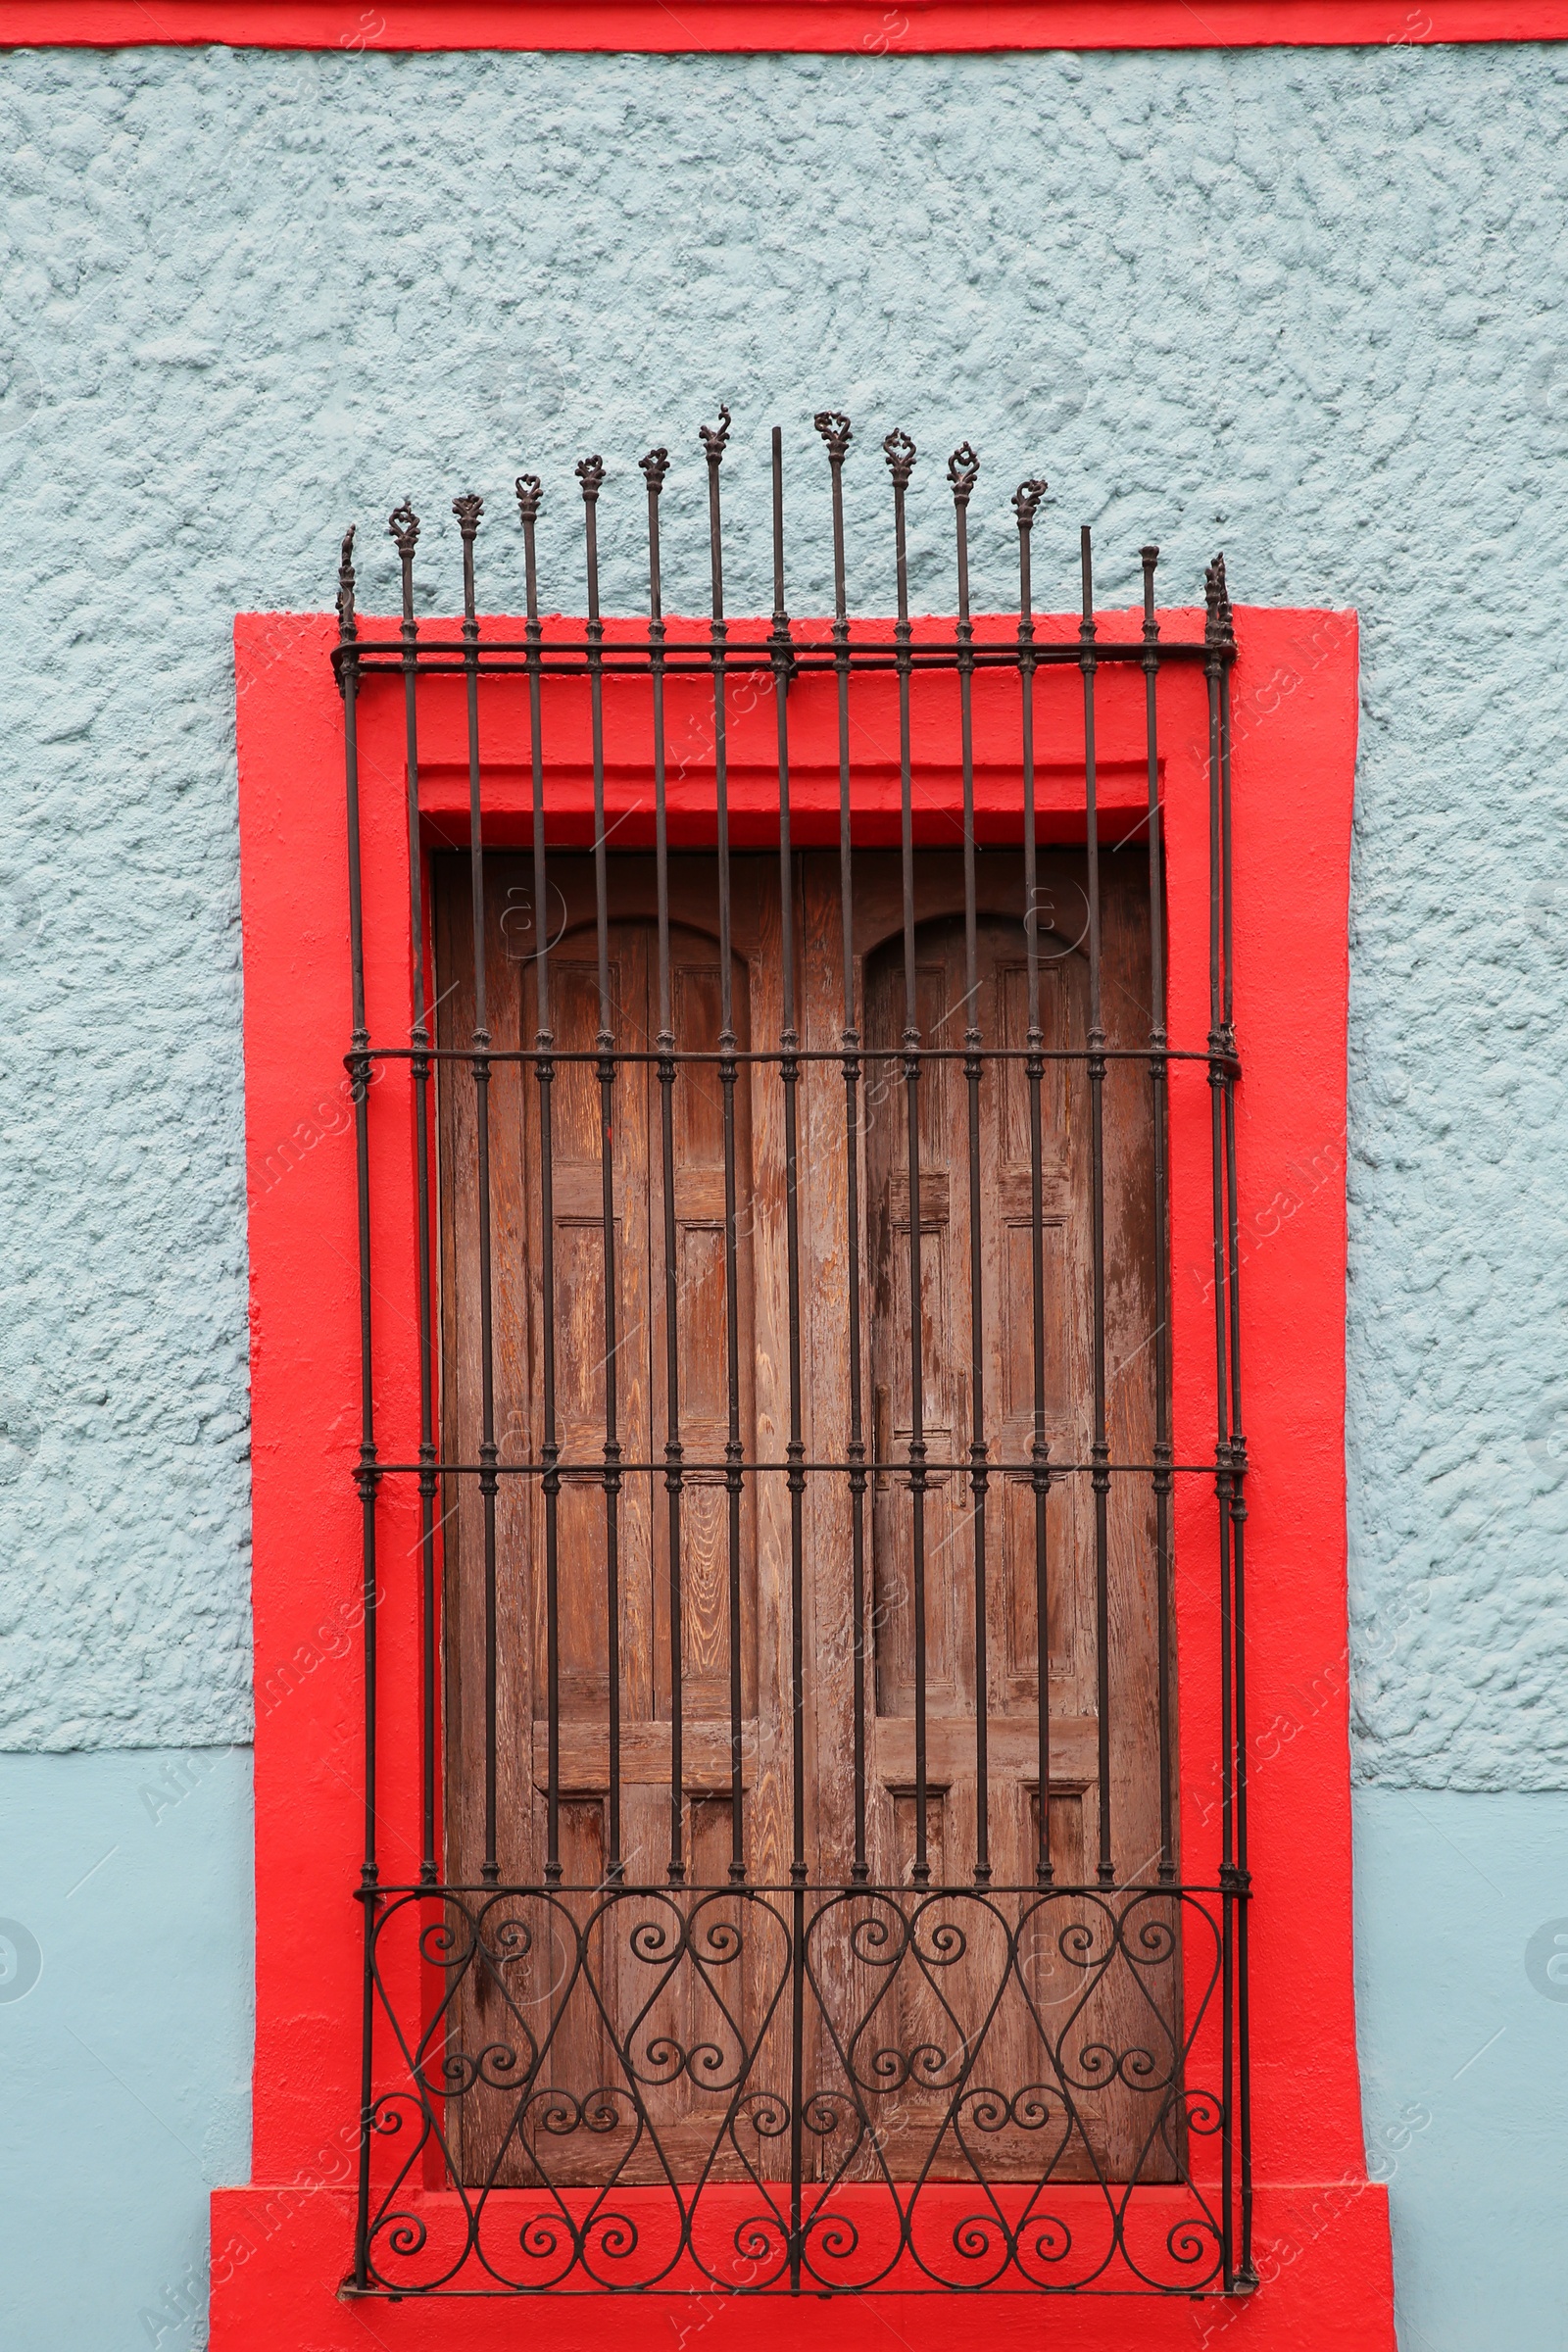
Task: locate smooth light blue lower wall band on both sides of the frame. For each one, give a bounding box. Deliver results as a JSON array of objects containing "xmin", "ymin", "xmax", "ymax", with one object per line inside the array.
[{"xmin": 0, "ymin": 1747, "xmax": 1568, "ymax": 2352}]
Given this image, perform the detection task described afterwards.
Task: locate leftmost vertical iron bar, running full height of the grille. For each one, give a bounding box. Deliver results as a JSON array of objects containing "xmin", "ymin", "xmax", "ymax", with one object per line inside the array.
[{"xmin": 338, "ymin": 527, "xmax": 381, "ymax": 2291}]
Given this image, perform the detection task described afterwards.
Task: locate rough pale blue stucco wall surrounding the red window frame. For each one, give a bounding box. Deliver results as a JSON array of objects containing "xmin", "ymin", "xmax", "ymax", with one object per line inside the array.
[{"xmin": 0, "ymin": 47, "xmax": 1568, "ymax": 1788}]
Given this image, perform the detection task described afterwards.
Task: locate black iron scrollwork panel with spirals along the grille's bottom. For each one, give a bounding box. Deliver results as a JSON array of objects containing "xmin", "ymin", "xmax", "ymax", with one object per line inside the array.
[{"xmin": 369, "ymin": 1886, "xmax": 1222, "ymax": 2295}]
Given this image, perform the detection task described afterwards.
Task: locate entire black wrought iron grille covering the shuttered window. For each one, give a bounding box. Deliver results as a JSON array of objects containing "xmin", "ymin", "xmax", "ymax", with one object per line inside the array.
[{"xmin": 334, "ymin": 412, "xmax": 1253, "ymax": 2295}]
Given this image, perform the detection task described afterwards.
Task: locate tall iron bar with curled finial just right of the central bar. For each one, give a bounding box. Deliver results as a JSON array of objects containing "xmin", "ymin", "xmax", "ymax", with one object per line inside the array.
[{"xmin": 813, "ymin": 410, "xmax": 870, "ymax": 1886}]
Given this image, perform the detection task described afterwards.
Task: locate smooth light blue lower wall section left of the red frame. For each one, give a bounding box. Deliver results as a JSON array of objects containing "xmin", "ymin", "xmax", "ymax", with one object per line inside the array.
[{"xmin": 0, "ymin": 1747, "xmax": 251, "ymax": 2352}]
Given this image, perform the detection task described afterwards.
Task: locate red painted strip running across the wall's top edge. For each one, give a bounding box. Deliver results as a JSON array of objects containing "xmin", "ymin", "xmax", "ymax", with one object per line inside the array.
[{"xmin": 0, "ymin": 0, "xmax": 1568, "ymax": 57}]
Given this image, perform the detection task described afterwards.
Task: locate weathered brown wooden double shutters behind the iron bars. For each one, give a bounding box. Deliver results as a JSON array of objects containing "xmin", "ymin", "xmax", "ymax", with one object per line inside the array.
[{"xmin": 435, "ymin": 852, "xmax": 1173, "ymax": 2180}]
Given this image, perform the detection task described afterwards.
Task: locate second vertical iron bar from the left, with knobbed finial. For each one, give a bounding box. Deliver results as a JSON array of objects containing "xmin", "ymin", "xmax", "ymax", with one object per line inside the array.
[{"xmin": 388, "ymin": 499, "xmax": 444, "ymax": 1886}]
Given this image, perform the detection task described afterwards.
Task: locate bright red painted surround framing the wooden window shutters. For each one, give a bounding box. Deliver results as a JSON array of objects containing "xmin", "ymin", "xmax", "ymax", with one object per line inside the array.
[{"xmin": 212, "ymin": 607, "xmax": 1394, "ymax": 2352}]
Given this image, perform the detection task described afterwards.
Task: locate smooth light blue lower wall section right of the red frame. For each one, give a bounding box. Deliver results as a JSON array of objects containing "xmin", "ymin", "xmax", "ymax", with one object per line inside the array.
[{"xmin": 1353, "ymin": 1788, "xmax": 1568, "ymax": 2352}]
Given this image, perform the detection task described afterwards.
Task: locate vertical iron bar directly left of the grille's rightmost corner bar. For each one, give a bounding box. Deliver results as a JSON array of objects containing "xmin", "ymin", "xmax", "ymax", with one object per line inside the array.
[{"xmin": 1138, "ymin": 548, "xmax": 1175, "ymax": 1886}]
